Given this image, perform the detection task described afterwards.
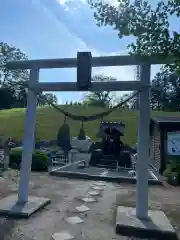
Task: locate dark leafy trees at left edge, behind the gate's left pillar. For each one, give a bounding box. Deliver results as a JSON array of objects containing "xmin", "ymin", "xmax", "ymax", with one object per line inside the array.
[{"xmin": 0, "ymin": 42, "xmax": 57, "ymax": 109}]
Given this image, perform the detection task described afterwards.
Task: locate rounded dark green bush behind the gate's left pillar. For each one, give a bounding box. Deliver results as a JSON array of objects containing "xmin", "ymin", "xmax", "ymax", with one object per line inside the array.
[{"xmin": 9, "ymin": 148, "xmax": 48, "ymax": 171}]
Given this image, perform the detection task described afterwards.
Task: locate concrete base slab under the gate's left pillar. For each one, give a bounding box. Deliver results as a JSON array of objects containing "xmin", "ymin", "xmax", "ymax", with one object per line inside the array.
[{"xmin": 0, "ymin": 195, "xmax": 51, "ymax": 218}]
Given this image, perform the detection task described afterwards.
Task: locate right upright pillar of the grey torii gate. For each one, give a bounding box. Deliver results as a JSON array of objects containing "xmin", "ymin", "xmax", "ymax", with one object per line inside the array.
[{"xmin": 136, "ymin": 64, "xmax": 151, "ymax": 220}]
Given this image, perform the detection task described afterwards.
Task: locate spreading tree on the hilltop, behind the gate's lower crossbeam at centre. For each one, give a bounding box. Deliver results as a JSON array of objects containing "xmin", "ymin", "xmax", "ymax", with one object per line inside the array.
[{"xmin": 83, "ymin": 75, "xmax": 116, "ymax": 107}]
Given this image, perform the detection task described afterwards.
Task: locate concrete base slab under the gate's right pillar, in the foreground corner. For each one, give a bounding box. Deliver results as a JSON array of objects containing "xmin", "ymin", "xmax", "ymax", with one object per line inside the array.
[{"xmin": 116, "ymin": 206, "xmax": 177, "ymax": 240}]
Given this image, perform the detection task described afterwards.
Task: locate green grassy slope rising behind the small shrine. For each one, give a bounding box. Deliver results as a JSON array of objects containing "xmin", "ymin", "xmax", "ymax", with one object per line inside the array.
[{"xmin": 0, "ymin": 106, "xmax": 180, "ymax": 144}]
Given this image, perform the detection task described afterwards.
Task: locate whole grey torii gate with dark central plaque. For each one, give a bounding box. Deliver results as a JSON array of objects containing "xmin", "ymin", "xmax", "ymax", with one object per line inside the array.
[{"xmin": 6, "ymin": 52, "xmax": 167, "ymax": 219}]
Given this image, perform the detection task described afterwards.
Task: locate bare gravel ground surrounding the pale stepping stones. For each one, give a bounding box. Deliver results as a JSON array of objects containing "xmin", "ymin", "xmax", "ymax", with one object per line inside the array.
[{"xmin": 0, "ymin": 171, "xmax": 180, "ymax": 240}]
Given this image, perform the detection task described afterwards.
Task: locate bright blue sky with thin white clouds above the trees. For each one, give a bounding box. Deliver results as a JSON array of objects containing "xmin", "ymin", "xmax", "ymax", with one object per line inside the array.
[{"xmin": 0, "ymin": 0, "xmax": 177, "ymax": 102}]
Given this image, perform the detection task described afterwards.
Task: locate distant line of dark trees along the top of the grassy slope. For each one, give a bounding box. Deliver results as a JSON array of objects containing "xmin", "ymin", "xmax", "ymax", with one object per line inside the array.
[{"xmin": 0, "ymin": 39, "xmax": 180, "ymax": 111}]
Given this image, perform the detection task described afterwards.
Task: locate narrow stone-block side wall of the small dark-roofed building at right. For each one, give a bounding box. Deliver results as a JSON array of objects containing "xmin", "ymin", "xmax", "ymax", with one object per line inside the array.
[{"xmin": 150, "ymin": 124, "xmax": 161, "ymax": 172}]
